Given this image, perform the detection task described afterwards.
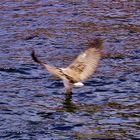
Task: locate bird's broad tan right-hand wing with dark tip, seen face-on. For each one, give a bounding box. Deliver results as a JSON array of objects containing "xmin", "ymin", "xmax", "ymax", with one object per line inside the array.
[{"xmin": 64, "ymin": 38, "xmax": 102, "ymax": 82}]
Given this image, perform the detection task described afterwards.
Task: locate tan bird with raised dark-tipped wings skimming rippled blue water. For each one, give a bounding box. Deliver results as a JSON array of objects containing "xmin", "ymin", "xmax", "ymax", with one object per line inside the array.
[{"xmin": 31, "ymin": 38, "xmax": 103, "ymax": 94}]
